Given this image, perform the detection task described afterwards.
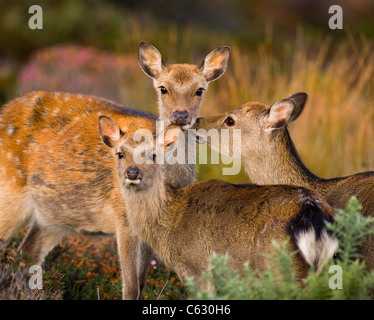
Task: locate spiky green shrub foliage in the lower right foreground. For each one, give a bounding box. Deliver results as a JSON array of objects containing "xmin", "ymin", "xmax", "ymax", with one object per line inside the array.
[{"xmin": 187, "ymin": 197, "xmax": 374, "ymax": 300}]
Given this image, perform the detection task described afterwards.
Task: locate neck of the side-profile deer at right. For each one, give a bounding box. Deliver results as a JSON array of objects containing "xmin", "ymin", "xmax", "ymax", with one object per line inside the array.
[{"xmin": 243, "ymin": 129, "xmax": 319, "ymax": 188}]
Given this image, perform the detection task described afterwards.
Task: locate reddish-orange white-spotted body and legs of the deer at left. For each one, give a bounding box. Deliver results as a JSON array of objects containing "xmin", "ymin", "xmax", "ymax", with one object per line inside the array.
[{"xmin": 0, "ymin": 92, "xmax": 156, "ymax": 298}]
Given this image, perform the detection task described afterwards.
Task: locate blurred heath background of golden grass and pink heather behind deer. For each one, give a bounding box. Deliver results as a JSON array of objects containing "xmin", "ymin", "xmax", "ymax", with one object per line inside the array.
[{"xmin": 0, "ymin": 0, "xmax": 374, "ymax": 182}]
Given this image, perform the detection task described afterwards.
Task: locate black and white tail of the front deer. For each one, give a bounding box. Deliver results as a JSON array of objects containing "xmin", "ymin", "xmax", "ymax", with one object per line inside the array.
[{"xmin": 287, "ymin": 202, "xmax": 339, "ymax": 273}]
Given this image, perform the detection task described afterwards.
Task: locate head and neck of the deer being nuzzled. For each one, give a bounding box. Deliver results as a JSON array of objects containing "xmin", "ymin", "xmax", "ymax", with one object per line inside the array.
[{"xmin": 139, "ymin": 42, "xmax": 230, "ymax": 187}]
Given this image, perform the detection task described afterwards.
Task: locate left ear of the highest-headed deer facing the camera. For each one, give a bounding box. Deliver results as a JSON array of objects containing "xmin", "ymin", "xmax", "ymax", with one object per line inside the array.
[{"xmin": 138, "ymin": 41, "xmax": 165, "ymax": 79}]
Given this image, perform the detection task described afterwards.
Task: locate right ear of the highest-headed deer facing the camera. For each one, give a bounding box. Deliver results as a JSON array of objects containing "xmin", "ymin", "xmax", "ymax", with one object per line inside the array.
[{"xmin": 200, "ymin": 47, "xmax": 230, "ymax": 82}]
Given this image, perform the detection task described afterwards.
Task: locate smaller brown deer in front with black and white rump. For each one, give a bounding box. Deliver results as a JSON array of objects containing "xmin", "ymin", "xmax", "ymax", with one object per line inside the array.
[{"xmin": 99, "ymin": 116, "xmax": 338, "ymax": 281}]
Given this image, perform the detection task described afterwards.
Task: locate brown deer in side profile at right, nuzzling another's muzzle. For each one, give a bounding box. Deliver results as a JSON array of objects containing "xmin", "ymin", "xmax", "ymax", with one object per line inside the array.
[{"xmin": 194, "ymin": 92, "xmax": 374, "ymax": 269}]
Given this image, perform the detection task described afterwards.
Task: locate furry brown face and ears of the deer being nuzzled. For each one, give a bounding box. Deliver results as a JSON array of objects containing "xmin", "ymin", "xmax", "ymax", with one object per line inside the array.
[{"xmin": 139, "ymin": 42, "xmax": 230, "ymax": 127}]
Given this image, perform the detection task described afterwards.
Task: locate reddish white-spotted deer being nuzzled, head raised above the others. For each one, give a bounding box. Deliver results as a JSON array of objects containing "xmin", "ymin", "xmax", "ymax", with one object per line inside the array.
[{"xmin": 0, "ymin": 42, "xmax": 229, "ymax": 299}]
